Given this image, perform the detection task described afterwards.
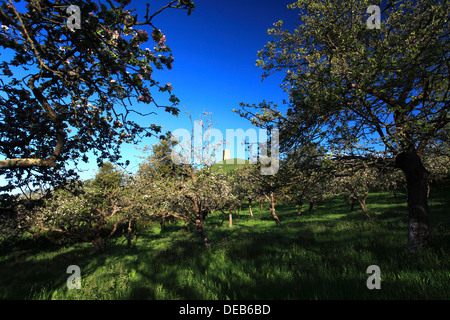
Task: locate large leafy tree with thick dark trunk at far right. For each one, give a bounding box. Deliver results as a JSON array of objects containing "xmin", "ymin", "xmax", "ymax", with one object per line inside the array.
[{"xmin": 239, "ymin": 0, "xmax": 450, "ymax": 251}]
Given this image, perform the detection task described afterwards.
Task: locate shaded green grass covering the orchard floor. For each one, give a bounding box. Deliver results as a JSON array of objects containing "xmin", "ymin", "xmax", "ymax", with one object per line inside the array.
[{"xmin": 0, "ymin": 182, "xmax": 450, "ymax": 300}]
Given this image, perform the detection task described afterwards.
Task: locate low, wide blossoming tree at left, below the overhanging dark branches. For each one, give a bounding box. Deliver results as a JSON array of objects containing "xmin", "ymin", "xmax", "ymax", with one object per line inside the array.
[{"xmin": 17, "ymin": 172, "xmax": 129, "ymax": 252}]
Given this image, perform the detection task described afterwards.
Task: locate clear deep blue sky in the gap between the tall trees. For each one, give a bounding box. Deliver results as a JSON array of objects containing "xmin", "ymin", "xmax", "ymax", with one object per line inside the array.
[{"xmin": 82, "ymin": 0, "xmax": 298, "ymax": 177}]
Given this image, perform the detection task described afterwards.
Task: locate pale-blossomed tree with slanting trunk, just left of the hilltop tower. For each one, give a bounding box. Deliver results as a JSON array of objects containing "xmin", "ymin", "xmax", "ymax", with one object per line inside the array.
[{"xmin": 137, "ymin": 113, "xmax": 237, "ymax": 247}]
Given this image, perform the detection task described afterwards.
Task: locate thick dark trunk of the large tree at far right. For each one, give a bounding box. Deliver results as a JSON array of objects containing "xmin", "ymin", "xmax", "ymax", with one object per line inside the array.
[{"xmin": 395, "ymin": 148, "xmax": 430, "ymax": 252}]
